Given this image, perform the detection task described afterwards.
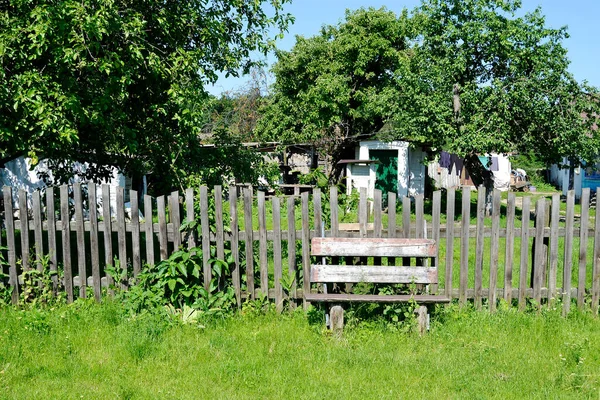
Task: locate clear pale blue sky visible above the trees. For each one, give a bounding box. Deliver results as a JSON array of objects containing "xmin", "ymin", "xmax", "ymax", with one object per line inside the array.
[{"xmin": 209, "ymin": 0, "xmax": 600, "ymax": 95}]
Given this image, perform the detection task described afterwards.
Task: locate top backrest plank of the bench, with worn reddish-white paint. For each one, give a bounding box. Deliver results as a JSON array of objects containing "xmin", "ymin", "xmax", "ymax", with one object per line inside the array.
[{"xmin": 311, "ymin": 237, "xmax": 437, "ymax": 257}]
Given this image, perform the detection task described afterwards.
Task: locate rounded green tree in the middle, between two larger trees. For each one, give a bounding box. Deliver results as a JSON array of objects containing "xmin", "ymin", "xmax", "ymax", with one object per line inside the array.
[{"xmin": 256, "ymin": 9, "xmax": 407, "ymax": 180}]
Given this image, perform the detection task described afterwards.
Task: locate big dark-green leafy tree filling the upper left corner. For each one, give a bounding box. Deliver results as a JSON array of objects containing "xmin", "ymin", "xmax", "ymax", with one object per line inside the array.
[{"xmin": 0, "ymin": 0, "xmax": 291, "ymax": 192}]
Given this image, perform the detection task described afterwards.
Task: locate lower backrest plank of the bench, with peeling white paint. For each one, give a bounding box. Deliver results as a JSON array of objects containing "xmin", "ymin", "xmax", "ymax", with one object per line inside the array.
[{"xmin": 310, "ymin": 264, "xmax": 438, "ymax": 284}]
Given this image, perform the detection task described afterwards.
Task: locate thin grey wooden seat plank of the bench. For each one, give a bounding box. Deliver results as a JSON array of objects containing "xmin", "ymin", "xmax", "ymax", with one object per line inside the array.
[{"xmin": 304, "ymin": 293, "xmax": 450, "ymax": 304}]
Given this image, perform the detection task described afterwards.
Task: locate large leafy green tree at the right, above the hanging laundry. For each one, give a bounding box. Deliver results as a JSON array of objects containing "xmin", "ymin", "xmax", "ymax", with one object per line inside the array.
[{"xmin": 389, "ymin": 0, "xmax": 600, "ymax": 192}]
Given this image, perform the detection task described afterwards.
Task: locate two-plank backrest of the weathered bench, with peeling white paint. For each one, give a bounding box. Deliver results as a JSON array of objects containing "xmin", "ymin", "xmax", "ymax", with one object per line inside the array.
[{"xmin": 310, "ymin": 237, "xmax": 438, "ymax": 284}]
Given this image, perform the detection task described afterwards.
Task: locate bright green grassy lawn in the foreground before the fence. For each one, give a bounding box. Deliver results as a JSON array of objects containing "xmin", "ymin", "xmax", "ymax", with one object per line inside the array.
[{"xmin": 0, "ymin": 302, "xmax": 600, "ymax": 399}]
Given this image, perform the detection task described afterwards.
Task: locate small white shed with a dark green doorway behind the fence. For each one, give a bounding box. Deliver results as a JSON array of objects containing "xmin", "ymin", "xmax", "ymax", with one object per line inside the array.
[{"xmin": 340, "ymin": 140, "xmax": 426, "ymax": 200}]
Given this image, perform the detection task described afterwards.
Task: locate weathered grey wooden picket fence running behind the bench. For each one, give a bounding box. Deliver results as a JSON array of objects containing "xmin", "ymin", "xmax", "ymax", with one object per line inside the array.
[{"xmin": 0, "ymin": 184, "xmax": 600, "ymax": 313}]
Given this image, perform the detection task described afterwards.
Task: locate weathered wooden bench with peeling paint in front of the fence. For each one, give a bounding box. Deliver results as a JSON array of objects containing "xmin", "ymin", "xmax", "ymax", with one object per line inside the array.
[{"xmin": 304, "ymin": 237, "xmax": 450, "ymax": 332}]
